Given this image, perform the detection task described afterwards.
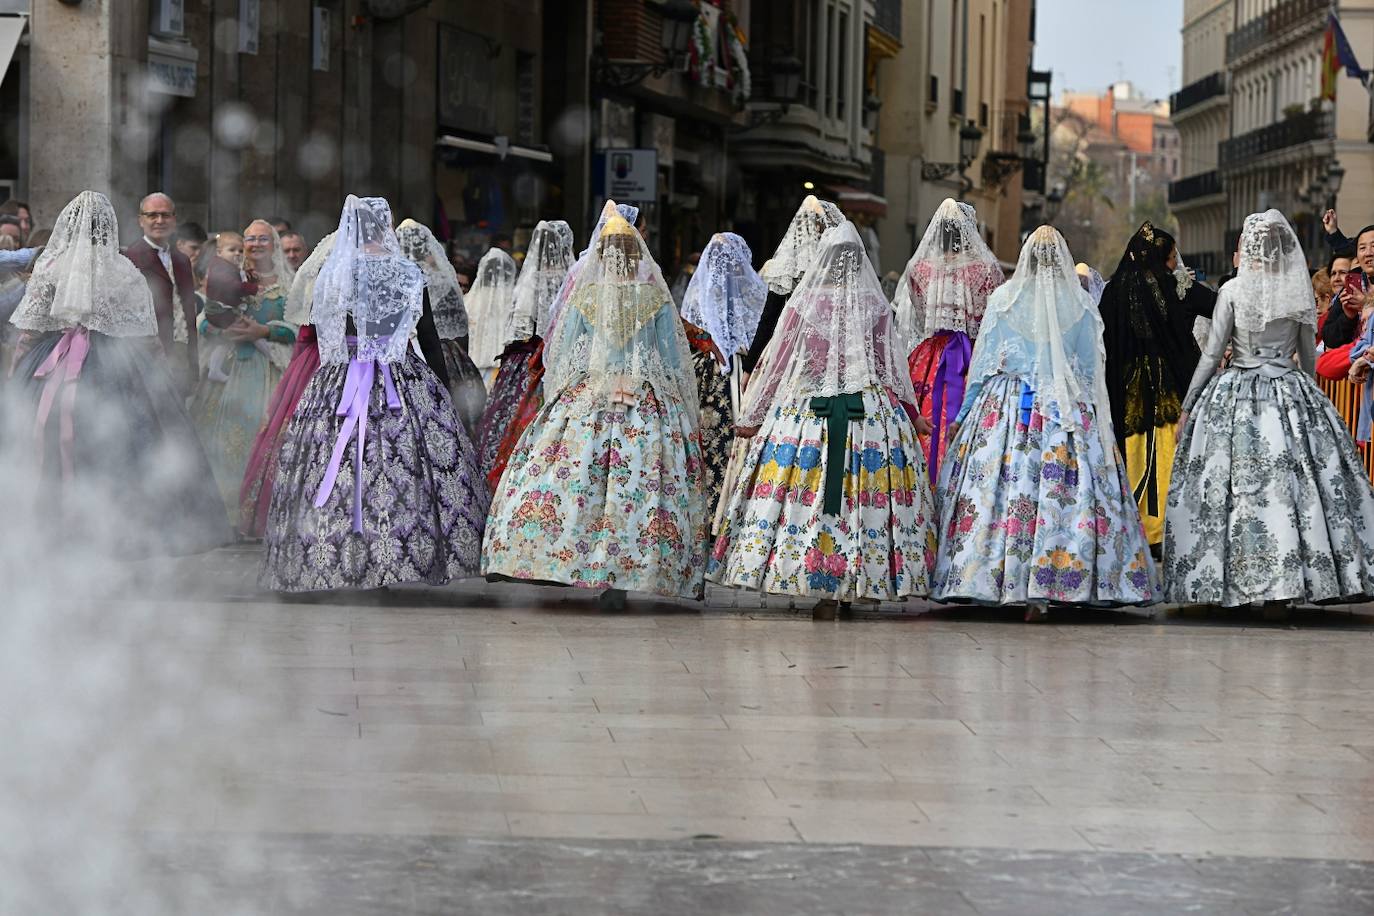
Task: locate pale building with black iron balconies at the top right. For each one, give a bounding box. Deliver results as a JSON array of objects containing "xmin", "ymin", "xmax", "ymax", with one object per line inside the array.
[{"xmin": 1171, "ymin": 0, "xmax": 1374, "ymax": 271}]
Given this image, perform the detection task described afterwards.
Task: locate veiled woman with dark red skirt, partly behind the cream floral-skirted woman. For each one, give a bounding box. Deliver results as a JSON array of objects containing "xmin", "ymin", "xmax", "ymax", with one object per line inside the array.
[{"xmin": 477, "ymin": 220, "xmax": 573, "ymax": 474}]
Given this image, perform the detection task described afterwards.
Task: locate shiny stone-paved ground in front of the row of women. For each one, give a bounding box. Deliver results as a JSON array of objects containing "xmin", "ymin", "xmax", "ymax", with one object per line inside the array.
[{"xmin": 16, "ymin": 548, "xmax": 1374, "ymax": 915}]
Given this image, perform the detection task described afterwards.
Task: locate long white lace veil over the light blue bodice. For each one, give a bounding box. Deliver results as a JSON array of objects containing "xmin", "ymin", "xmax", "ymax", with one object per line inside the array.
[{"xmin": 969, "ymin": 225, "xmax": 1116, "ymax": 456}]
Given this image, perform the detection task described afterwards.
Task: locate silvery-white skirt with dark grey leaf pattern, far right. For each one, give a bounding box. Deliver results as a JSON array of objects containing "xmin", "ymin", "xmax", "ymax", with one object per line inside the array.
[{"xmin": 1164, "ymin": 368, "xmax": 1374, "ymax": 607}]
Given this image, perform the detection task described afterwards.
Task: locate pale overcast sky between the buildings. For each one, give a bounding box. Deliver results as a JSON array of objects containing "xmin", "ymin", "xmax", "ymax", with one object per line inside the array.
[{"xmin": 1035, "ymin": 0, "xmax": 1183, "ymax": 99}]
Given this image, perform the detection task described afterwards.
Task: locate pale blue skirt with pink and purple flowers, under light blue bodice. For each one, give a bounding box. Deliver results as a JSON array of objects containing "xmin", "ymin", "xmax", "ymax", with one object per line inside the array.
[{"xmin": 933, "ymin": 375, "xmax": 1160, "ymax": 607}]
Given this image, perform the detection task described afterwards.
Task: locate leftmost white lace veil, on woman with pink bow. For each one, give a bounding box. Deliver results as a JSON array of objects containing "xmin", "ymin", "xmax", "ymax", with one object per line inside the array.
[{"xmin": 10, "ymin": 191, "xmax": 158, "ymax": 336}]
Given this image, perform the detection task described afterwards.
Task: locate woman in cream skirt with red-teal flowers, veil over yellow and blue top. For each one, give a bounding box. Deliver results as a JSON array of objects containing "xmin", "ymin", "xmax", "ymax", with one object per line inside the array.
[{"xmin": 482, "ymin": 216, "xmax": 706, "ymax": 607}]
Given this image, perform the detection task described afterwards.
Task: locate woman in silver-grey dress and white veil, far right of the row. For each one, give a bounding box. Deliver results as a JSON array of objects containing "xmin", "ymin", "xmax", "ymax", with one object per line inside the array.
[{"xmin": 1164, "ymin": 210, "xmax": 1374, "ymax": 607}]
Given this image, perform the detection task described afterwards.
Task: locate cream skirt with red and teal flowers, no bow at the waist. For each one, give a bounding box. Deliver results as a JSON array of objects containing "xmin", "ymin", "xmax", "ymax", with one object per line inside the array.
[{"xmin": 482, "ymin": 382, "xmax": 706, "ymax": 597}]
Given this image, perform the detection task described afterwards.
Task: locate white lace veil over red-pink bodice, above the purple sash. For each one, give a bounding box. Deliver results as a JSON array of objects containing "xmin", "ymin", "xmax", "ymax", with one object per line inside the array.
[{"xmin": 892, "ymin": 198, "xmax": 1004, "ymax": 347}]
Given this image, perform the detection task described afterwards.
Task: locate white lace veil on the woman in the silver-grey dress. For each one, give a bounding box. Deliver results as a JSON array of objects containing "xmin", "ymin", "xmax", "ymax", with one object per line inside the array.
[{"xmin": 1221, "ymin": 210, "xmax": 1316, "ymax": 331}]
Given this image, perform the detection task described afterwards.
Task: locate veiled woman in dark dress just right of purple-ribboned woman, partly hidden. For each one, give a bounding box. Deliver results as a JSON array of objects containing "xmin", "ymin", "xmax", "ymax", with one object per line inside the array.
[{"xmin": 395, "ymin": 219, "xmax": 486, "ymax": 437}]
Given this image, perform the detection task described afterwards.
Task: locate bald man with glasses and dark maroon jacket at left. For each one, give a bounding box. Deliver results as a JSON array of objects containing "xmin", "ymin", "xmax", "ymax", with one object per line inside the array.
[{"xmin": 124, "ymin": 194, "xmax": 201, "ymax": 397}]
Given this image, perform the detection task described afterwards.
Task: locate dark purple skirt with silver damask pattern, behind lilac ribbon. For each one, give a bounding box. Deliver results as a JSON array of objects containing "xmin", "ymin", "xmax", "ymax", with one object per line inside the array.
[{"xmin": 258, "ymin": 352, "xmax": 488, "ymax": 592}]
